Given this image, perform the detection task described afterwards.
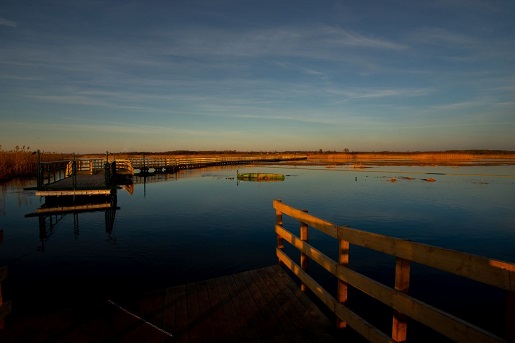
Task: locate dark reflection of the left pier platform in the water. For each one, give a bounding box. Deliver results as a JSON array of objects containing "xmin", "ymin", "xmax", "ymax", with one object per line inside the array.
[{"xmin": 25, "ymin": 193, "xmax": 120, "ymax": 251}]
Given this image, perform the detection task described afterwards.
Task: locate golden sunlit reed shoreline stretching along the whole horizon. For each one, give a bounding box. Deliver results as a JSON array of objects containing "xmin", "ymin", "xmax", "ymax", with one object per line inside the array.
[{"xmin": 0, "ymin": 147, "xmax": 515, "ymax": 180}]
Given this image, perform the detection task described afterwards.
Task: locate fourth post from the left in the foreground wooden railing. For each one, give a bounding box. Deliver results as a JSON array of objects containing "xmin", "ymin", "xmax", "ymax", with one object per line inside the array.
[{"xmin": 392, "ymin": 257, "xmax": 410, "ymax": 342}]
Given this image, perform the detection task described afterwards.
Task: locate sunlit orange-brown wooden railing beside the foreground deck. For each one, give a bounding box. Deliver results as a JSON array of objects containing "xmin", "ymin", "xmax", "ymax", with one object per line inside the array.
[{"xmin": 273, "ymin": 200, "xmax": 515, "ymax": 342}]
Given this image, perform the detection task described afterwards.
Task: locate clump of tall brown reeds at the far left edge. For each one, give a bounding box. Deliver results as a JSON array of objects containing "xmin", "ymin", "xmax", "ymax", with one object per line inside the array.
[{"xmin": 0, "ymin": 146, "xmax": 69, "ymax": 180}]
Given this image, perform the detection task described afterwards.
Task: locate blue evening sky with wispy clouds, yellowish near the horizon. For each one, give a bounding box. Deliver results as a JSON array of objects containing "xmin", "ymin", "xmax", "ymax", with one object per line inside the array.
[{"xmin": 0, "ymin": 0, "xmax": 515, "ymax": 153}]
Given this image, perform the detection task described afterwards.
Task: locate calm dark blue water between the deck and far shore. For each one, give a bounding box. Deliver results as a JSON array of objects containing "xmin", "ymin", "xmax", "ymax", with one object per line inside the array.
[{"xmin": 0, "ymin": 165, "xmax": 515, "ymax": 342}]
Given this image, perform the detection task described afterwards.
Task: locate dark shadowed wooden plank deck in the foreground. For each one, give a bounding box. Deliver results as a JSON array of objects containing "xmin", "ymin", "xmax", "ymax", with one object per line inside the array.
[{"xmin": 0, "ymin": 266, "xmax": 346, "ymax": 343}]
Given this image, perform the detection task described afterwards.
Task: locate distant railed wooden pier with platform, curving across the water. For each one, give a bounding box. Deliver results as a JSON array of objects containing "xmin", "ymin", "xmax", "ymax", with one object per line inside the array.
[{"xmin": 36, "ymin": 154, "xmax": 307, "ymax": 196}]
